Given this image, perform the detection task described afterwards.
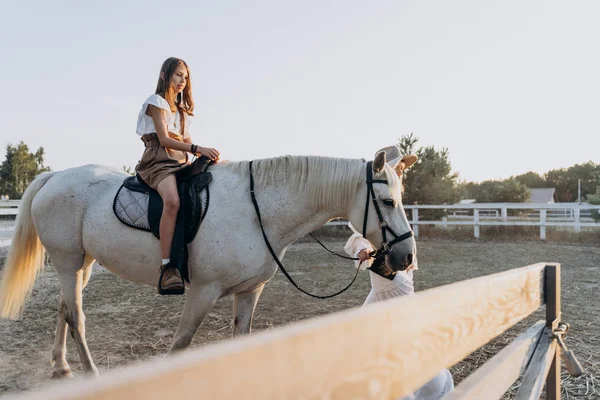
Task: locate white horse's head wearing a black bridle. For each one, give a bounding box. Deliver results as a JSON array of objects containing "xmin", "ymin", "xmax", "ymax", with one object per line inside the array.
[{"xmin": 350, "ymin": 146, "xmax": 418, "ymax": 272}]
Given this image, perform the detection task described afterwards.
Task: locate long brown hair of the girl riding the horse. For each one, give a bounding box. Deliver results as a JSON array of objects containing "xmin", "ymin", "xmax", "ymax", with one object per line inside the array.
[{"xmin": 155, "ymin": 57, "xmax": 194, "ymax": 135}]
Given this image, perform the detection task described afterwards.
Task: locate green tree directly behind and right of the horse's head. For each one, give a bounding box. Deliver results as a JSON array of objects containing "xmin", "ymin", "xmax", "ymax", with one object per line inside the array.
[{"xmin": 398, "ymin": 133, "xmax": 463, "ymax": 204}]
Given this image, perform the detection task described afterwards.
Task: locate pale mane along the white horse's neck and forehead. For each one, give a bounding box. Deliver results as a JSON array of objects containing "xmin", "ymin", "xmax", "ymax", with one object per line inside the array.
[{"xmin": 215, "ymin": 156, "xmax": 400, "ymax": 207}]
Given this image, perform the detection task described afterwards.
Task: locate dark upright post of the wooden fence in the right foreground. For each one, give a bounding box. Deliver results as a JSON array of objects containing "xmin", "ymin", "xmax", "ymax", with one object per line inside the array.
[{"xmin": 544, "ymin": 264, "xmax": 561, "ymax": 400}]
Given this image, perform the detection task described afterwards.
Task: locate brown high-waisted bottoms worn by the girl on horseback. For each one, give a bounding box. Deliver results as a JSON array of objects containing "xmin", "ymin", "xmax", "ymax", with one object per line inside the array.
[{"xmin": 135, "ymin": 133, "xmax": 188, "ymax": 190}]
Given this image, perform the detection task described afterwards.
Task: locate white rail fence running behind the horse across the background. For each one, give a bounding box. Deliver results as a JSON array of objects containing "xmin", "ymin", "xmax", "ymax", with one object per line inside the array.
[{"xmin": 0, "ymin": 200, "xmax": 600, "ymax": 240}]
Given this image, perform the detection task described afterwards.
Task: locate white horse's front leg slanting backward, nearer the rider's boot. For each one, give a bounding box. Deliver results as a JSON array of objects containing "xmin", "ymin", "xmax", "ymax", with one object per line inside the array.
[{"xmin": 169, "ymin": 283, "xmax": 221, "ymax": 353}]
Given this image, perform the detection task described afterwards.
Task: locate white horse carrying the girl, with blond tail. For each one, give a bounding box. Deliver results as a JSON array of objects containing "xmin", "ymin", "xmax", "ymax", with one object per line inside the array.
[{"xmin": 0, "ymin": 147, "xmax": 416, "ymax": 377}]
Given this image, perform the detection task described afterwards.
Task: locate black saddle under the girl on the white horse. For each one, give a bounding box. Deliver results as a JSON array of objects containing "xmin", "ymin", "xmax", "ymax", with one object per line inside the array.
[{"xmin": 115, "ymin": 156, "xmax": 212, "ymax": 282}]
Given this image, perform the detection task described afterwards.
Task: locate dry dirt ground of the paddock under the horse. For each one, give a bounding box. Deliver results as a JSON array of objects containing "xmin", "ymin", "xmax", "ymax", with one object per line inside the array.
[{"xmin": 0, "ymin": 238, "xmax": 600, "ymax": 399}]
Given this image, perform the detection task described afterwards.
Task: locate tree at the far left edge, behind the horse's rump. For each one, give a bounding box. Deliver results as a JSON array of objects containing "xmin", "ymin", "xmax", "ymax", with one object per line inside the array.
[{"xmin": 0, "ymin": 142, "xmax": 50, "ymax": 199}]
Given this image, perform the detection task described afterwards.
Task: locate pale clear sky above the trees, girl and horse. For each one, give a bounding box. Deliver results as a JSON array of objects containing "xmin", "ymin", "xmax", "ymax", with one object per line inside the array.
[{"xmin": 0, "ymin": 0, "xmax": 600, "ymax": 181}]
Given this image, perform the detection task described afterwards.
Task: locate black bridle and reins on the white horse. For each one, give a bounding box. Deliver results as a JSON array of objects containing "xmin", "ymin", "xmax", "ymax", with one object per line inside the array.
[{"xmin": 248, "ymin": 161, "xmax": 413, "ymax": 299}]
